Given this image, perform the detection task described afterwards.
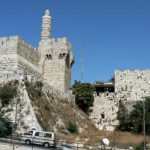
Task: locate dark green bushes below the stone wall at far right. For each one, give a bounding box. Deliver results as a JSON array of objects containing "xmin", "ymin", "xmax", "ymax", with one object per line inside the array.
[{"xmin": 117, "ymin": 97, "xmax": 150, "ymax": 135}]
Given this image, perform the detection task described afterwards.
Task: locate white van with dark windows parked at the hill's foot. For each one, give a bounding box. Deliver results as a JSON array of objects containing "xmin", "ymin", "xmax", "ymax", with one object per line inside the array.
[{"xmin": 22, "ymin": 130, "xmax": 56, "ymax": 147}]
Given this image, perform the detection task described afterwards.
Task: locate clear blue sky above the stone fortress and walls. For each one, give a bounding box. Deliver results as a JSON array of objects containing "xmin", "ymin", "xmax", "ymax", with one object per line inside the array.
[{"xmin": 0, "ymin": 0, "xmax": 150, "ymax": 83}]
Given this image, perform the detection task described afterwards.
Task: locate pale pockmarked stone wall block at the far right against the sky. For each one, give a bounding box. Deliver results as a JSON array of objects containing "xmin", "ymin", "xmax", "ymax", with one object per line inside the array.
[{"xmin": 115, "ymin": 70, "xmax": 150, "ymax": 109}]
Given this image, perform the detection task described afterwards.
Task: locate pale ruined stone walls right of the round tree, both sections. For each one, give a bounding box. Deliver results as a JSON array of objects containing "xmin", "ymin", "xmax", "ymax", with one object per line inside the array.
[{"xmin": 90, "ymin": 70, "xmax": 150, "ymax": 130}]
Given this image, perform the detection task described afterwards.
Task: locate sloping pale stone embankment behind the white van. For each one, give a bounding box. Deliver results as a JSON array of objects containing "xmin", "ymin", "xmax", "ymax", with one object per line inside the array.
[{"xmin": 0, "ymin": 81, "xmax": 43, "ymax": 133}]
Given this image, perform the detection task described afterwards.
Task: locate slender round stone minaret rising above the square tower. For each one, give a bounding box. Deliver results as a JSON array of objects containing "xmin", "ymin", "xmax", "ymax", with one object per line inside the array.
[{"xmin": 41, "ymin": 9, "xmax": 52, "ymax": 40}]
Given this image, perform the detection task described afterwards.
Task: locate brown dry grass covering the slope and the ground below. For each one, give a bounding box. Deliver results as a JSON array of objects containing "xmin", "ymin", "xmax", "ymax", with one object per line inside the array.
[{"xmin": 25, "ymin": 82, "xmax": 150, "ymax": 148}]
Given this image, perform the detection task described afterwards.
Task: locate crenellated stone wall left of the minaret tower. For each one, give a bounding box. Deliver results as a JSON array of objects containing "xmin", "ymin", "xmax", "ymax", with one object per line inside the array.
[{"xmin": 0, "ymin": 36, "xmax": 41, "ymax": 82}]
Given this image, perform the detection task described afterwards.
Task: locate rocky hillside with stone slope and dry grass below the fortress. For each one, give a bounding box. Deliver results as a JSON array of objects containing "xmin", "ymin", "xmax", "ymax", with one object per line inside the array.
[{"xmin": 0, "ymin": 81, "xmax": 97, "ymax": 143}]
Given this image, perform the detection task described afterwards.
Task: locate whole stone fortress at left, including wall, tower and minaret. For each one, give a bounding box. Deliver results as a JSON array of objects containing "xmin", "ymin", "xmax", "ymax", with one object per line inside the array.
[{"xmin": 0, "ymin": 9, "xmax": 74, "ymax": 91}]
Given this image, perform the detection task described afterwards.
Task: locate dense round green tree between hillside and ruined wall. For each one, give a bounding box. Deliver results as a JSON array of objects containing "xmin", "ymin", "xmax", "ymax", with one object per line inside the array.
[{"xmin": 72, "ymin": 81, "xmax": 94, "ymax": 114}]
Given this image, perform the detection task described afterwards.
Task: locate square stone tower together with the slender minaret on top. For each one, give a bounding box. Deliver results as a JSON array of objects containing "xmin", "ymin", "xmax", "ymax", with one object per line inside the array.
[{"xmin": 38, "ymin": 9, "xmax": 74, "ymax": 91}]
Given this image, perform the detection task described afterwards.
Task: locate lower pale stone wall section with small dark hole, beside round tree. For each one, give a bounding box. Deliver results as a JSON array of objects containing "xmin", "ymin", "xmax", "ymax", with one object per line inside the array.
[{"xmin": 90, "ymin": 92, "xmax": 118, "ymax": 131}]
